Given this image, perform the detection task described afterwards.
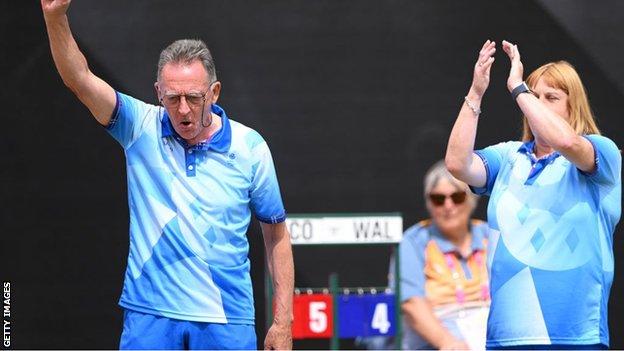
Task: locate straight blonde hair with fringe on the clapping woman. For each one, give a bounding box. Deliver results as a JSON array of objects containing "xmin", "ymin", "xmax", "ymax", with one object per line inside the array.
[{"xmin": 522, "ymin": 61, "xmax": 600, "ymax": 141}]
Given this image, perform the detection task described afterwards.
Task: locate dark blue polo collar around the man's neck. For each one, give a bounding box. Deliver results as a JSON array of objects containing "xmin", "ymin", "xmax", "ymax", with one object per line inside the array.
[{"xmin": 161, "ymin": 104, "xmax": 232, "ymax": 153}]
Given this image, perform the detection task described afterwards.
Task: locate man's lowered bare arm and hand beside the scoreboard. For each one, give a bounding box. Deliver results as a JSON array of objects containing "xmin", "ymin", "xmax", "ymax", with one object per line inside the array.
[{"xmin": 260, "ymin": 222, "xmax": 295, "ymax": 350}]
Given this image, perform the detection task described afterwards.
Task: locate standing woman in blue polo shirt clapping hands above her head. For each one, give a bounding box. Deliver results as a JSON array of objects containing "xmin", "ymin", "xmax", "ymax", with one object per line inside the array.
[{"xmin": 446, "ymin": 40, "xmax": 622, "ymax": 349}]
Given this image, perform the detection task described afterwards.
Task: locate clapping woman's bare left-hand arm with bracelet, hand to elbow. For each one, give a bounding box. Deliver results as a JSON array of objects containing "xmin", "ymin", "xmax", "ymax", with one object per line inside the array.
[{"xmin": 444, "ymin": 40, "xmax": 496, "ymax": 187}]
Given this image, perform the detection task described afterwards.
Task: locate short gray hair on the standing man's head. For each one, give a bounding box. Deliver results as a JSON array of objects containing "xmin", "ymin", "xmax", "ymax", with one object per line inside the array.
[{"xmin": 156, "ymin": 39, "xmax": 217, "ymax": 82}]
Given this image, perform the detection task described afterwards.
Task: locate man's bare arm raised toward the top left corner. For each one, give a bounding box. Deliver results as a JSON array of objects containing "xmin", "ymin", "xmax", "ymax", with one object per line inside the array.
[{"xmin": 41, "ymin": 0, "xmax": 116, "ymax": 126}]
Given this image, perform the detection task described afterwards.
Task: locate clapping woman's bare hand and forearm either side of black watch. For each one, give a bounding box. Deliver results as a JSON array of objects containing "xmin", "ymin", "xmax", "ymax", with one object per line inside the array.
[{"xmin": 503, "ymin": 41, "xmax": 596, "ymax": 172}]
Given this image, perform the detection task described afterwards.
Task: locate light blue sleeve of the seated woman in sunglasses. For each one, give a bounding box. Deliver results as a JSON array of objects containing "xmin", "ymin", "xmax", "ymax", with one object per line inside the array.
[{"xmin": 399, "ymin": 227, "xmax": 428, "ymax": 302}]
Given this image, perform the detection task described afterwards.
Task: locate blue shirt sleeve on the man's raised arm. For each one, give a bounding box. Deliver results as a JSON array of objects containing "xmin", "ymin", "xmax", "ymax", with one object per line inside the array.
[{"xmin": 106, "ymin": 92, "xmax": 159, "ymax": 149}]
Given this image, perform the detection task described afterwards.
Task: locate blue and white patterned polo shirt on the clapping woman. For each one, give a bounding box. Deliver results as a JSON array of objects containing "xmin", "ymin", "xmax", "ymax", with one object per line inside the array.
[{"xmin": 473, "ymin": 135, "xmax": 622, "ymax": 348}]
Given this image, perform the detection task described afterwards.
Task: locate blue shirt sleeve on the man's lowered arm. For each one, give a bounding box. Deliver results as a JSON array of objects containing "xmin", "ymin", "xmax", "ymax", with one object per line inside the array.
[{"xmin": 248, "ymin": 131, "xmax": 286, "ymax": 224}]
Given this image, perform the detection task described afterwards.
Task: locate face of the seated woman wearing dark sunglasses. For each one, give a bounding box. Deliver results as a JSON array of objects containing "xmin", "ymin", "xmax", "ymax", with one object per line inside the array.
[{"xmin": 427, "ymin": 179, "xmax": 472, "ymax": 235}]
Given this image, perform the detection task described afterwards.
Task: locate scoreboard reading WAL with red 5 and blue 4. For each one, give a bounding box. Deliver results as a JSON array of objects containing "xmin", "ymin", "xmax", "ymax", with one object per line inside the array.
[{"xmin": 265, "ymin": 213, "xmax": 403, "ymax": 349}]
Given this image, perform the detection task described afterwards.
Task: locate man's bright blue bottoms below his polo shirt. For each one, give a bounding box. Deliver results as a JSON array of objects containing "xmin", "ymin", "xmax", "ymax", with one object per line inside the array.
[{"xmin": 119, "ymin": 309, "xmax": 256, "ymax": 350}]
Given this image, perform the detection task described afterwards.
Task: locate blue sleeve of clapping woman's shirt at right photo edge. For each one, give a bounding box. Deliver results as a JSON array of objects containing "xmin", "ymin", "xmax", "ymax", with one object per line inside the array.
[{"xmin": 581, "ymin": 134, "xmax": 622, "ymax": 186}]
